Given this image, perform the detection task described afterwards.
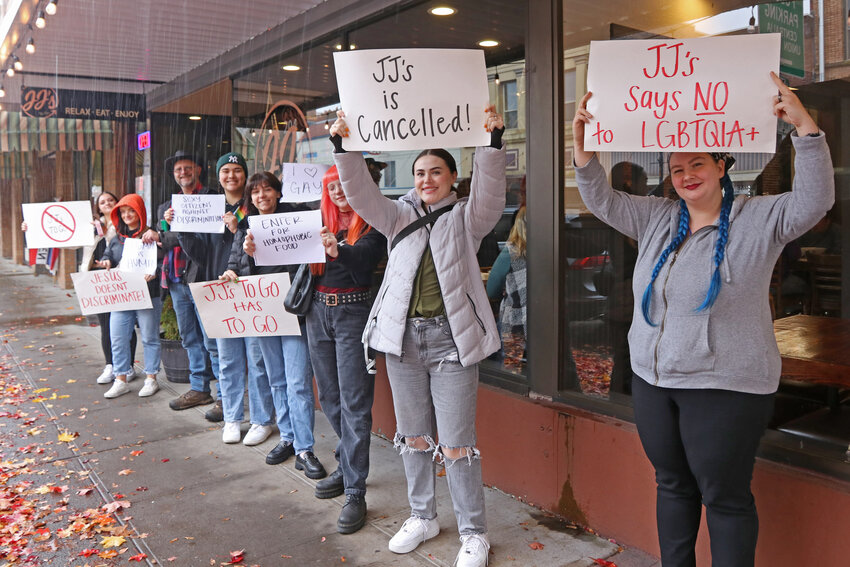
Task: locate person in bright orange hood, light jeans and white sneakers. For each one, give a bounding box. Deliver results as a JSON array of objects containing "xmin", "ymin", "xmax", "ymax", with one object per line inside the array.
[{"xmin": 97, "ymin": 193, "xmax": 162, "ymax": 398}]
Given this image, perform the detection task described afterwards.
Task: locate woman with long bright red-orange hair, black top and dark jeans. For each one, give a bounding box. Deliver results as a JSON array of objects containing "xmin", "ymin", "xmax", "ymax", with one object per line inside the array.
[{"xmin": 307, "ymin": 166, "xmax": 387, "ymax": 534}]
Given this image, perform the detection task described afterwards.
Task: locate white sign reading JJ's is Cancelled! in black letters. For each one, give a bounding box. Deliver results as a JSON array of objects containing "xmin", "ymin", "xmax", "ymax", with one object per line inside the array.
[{"xmin": 334, "ymin": 49, "xmax": 490, "ymax": 151}]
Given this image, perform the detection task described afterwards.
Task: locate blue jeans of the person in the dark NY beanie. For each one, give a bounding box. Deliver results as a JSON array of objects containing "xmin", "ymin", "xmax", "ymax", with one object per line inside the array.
[{"xmin": 216, "ymin": 337, "xmax": 274, "ymax": 425}]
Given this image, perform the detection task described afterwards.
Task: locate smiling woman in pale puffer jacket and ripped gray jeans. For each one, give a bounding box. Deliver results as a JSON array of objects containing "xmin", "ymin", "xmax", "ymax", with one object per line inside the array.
[{"xmin": 330, "ymin": 106, "xmax": 506, "ymax": 567}]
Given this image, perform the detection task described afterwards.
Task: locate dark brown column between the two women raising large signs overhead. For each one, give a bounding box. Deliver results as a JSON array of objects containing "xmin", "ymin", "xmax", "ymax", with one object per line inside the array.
[{"xmin": 526, "ymin": 0, "xmax": 569, "ymax": 398}]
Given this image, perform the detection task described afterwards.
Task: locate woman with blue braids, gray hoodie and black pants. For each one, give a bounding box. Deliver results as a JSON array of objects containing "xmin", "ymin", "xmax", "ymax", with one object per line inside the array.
[{"xmin": 573, "ymin": 73, "xmax": 835, "ymax": 567}]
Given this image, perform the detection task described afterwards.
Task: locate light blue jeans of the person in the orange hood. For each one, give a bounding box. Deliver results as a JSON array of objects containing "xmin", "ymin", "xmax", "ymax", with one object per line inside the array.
[{"xmin": 109, "ymin": 297, "xmax": 162, "ymax": 376}]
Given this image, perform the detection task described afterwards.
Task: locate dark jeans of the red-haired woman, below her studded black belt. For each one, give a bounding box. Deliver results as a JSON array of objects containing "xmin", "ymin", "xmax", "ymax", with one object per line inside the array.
[{"xmin": 307, "ymin": 301, "xmax": 375, "ymax": 495}]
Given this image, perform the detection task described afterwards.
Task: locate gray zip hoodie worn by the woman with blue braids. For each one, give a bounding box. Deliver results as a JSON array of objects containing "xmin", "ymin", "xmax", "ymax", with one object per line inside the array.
[{"xmin": 576, "ymin": 133, "xmax": 835, "ymax": 394}]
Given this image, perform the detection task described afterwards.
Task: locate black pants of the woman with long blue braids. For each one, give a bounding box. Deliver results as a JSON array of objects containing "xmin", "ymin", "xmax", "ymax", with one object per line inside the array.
[{"xmin": 632, "ymin": 376, "xmax": 773, "ymax": 567}]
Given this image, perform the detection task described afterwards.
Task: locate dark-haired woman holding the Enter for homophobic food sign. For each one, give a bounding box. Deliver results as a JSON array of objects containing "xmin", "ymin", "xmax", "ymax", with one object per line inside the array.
[{"xmin": 222, "ymin": 171, "xmax": 327, "ymax": 479}]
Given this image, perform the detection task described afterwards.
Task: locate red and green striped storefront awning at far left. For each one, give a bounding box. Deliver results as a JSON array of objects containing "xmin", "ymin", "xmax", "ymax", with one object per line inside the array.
[{"xmin": 0, "ymin": 110, "xmax": 114, "ymax": 152}]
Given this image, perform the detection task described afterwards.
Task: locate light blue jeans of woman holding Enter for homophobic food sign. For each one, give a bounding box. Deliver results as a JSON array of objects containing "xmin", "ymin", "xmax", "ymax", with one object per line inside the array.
[{"xmin": 257, "ymin": 335, "xmax": 316, "ymax": 453}]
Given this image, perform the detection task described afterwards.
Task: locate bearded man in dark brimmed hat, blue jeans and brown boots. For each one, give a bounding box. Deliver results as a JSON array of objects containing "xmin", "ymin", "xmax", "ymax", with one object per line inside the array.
[{"xmin": 142, "ymin": 151, "xmax": 218, "ymax": 410}]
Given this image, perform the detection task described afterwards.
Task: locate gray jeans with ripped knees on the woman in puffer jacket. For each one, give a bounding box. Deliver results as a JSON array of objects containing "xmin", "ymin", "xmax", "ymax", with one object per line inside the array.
[{"xmin": 387, "ymin": 316, "xmax": 487, "ymax": 535}]
